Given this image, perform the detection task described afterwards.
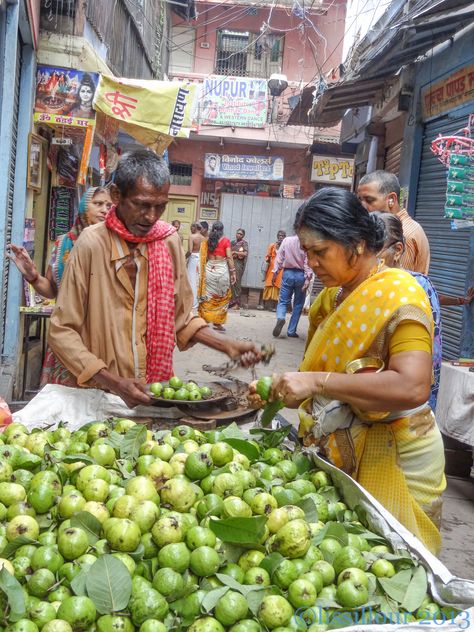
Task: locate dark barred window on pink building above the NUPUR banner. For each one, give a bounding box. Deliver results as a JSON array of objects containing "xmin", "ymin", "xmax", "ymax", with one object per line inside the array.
[{"xmin": 215, "ymin": 29, "xmax": 283, "ymax": 77}]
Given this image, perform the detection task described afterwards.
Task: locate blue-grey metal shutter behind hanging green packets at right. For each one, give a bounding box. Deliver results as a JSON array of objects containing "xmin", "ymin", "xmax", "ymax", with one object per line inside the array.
[{"xmin": 415, "ymin": 116, "xmax": 470, "ymax": 359}]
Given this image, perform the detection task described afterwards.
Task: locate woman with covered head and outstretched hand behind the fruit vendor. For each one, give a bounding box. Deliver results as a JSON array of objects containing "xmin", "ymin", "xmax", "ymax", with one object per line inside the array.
[{"xmin": 9, "ymin": 187, "xmax": 112, "ymax": 386}]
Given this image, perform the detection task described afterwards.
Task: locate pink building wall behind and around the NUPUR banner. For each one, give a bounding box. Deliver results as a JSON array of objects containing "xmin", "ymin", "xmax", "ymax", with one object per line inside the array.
[{"xmin": 168, "ymin": 0, "xmax": 346, "ymax": 218}]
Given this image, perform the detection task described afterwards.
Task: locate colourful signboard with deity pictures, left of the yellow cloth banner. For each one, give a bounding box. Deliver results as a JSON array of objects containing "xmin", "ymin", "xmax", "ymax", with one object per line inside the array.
[{"xmin": 34, "ymin": 65, "xmax": 99, "ymax": 129}]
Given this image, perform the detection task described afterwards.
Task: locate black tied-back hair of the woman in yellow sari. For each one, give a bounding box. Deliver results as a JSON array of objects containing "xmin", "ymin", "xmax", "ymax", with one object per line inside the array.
[{"xmin": 294, "ymin": 187, "xmax": 385, "ymax": 255}]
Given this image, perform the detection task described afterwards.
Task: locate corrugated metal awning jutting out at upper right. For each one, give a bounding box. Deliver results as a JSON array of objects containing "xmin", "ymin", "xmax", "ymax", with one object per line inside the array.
[{"xmin": 288, "ymin": 0, "xmax": 474, "ymax": 127}]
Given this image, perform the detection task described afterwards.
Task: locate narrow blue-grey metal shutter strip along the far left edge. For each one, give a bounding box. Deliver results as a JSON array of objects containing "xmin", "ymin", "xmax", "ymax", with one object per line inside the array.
[{"xmin": 0, "ymin": 41, "xmax": 22, "ymax": 352}]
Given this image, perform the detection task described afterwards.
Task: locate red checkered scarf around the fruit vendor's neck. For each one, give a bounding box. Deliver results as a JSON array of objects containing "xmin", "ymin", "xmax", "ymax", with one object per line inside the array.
[{"xmin": 105, "ymin": 206, "xmax": 176, "ymax": 383}]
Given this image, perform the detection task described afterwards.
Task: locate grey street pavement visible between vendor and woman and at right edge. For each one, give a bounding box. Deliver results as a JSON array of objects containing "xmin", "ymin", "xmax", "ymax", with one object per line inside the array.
[{"xmin": 174, "ymin": 310, "xmax": 474, "ymax": 580}]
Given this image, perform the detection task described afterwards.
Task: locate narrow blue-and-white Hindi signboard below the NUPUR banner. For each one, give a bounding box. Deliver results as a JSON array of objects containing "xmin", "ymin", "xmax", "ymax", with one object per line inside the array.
[{"xmin": 204, "ymin": 154, "xmax": 284, "ymax": 180}]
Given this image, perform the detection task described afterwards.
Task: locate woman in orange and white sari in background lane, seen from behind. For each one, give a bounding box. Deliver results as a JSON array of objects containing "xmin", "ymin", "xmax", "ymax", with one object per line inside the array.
[{"xmin": 198, "ymin": 222, "xmax": 236, "ymax": 331}]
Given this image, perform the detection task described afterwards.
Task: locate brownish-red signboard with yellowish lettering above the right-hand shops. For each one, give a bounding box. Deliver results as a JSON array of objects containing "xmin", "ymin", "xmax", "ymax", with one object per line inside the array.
[{"xmin": 421, "ymin": 64, "xmax": 474, "ymax": 121}]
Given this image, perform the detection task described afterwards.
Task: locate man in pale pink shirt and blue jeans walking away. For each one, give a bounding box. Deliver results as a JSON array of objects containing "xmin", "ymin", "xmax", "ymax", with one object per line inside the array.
[{"xmin": 273, "ymin": 235, "xmax": 313, "ymax": 338}]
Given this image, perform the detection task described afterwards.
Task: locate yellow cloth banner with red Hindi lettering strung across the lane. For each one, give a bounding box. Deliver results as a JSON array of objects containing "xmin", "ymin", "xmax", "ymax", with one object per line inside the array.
[{"xmin": 94, "ymin": 75, "xmax": 198, "ymax": 153}]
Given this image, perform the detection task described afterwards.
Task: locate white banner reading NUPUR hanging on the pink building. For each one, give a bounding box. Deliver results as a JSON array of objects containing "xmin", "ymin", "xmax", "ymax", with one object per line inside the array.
[{"xmin": 199, "ymin": 76, "xmax": 268, "ymax": 127}]
